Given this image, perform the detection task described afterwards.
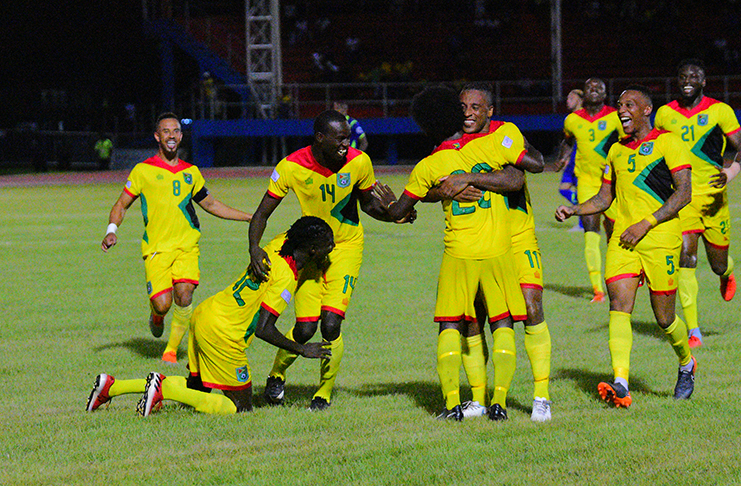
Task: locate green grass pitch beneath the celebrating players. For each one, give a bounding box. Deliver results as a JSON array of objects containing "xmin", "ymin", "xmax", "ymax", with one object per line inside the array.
[{"xmin": 0, "ymin": 174, "xmax": 741, "ymax": 485}]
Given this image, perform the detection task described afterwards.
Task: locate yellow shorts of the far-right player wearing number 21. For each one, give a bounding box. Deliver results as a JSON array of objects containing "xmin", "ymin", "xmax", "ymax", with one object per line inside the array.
[{"xmin": 679, "ymin": 191, "xmax": 731, "ymax": 248}]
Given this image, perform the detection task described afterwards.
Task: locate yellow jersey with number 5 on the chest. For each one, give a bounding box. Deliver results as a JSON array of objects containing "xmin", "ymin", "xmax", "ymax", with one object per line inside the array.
[{"xmin": 604, "ymin": 128, "xmax": 692, "ymax": 235}]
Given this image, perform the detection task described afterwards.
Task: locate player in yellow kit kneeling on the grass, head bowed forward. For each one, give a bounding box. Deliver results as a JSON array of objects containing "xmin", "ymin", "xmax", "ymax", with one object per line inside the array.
[{"xmin": 86, "ymin": 216, "xmax": 334, "ymax": 417}]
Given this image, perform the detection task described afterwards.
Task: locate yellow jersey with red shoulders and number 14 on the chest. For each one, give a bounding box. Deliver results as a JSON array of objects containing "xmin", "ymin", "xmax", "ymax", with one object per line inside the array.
[{"xmin": 268, "ymin": 146, "xmax": 376, "ymax": 248}]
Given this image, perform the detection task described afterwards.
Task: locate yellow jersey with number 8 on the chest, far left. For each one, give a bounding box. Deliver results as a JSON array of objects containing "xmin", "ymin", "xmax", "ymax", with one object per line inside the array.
[{"xmin": 124, "ymin": 155, "xmax": 208, "ymax": 257}]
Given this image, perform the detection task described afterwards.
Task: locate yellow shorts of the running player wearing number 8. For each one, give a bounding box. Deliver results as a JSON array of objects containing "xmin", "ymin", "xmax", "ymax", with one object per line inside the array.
[{"xmin": 144, "ymin": 247, "xmax": 201, "ymax": 299}]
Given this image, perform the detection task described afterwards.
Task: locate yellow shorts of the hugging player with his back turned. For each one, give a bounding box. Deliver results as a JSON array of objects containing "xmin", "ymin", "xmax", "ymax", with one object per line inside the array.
[{"xmin": 435, "ymin": 252, "xmax": 527, "ymax": 322}]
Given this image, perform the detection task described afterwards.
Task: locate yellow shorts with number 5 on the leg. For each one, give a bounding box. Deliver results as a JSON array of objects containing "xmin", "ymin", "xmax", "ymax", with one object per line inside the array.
[{"xmin": 605, "ymin": 231, "xmax": 682, "ymax": 294}]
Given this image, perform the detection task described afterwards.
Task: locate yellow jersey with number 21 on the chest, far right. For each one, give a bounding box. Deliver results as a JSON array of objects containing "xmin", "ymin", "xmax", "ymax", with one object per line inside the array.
[{"xmin": 655, "ymin": 96, "xmax": 741, "ymax": 195}]
